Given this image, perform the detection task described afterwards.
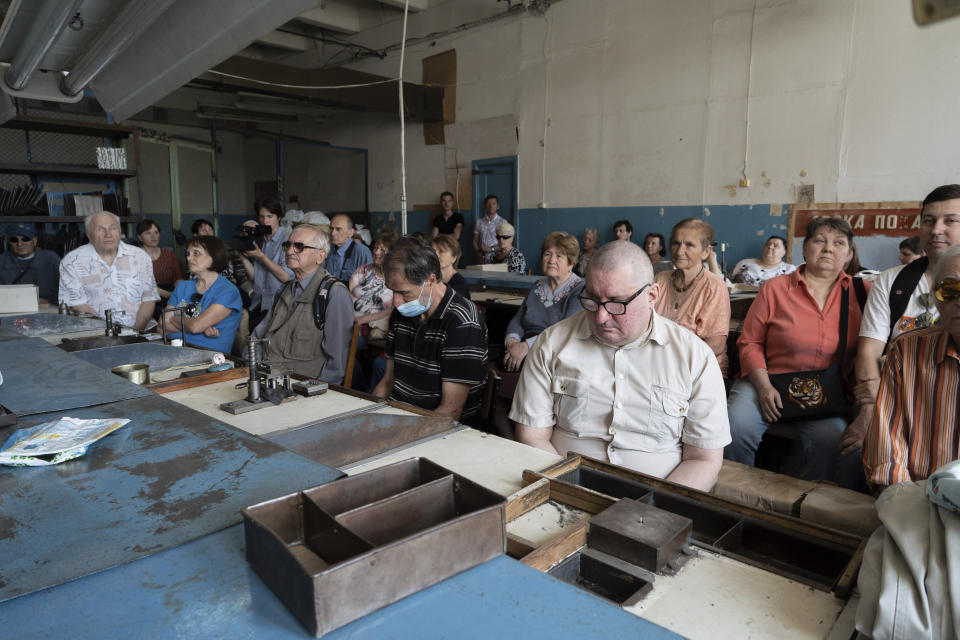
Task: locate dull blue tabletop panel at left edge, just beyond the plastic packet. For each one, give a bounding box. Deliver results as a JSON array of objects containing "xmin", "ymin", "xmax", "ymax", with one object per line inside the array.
[{"xmin": 0, "ymin": 338, "xmax": 153, "ymax": 416}]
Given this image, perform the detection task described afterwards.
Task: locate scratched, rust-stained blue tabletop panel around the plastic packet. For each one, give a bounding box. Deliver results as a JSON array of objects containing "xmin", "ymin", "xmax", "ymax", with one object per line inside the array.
[{"xmin": 0, "ymin": 392, "xmax": 343, "ymax": 600}]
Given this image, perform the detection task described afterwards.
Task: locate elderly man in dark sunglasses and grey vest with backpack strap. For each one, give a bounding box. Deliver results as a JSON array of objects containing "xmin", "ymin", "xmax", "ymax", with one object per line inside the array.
[{"xmin": 254, "ymin": 224, "xmax": 353, "ymax": 384}]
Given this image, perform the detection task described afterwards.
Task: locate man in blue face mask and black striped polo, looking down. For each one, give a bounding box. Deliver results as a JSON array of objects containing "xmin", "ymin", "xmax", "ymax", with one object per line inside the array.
[{"xmin": 373, "ymin": 237, "xmax": 487, "ymax": 420}]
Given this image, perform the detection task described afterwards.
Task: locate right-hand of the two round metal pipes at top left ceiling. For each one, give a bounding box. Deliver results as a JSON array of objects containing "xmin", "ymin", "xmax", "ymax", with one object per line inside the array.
[{"xmin": 60, "ymin": 0, "xmax": 174, "ymax": 97}]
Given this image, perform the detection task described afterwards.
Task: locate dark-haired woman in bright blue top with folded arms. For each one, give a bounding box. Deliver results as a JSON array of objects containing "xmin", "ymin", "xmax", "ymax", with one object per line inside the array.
[{"xmin": 165, "ymin": 236, "xmax": 243, "ymax": 353}]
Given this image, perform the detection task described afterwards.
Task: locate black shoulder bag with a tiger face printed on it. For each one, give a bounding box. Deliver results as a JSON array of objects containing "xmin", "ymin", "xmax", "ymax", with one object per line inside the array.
[{"xmin": 770, "ymin": 289, "xmax": 853, "ymax": 422}]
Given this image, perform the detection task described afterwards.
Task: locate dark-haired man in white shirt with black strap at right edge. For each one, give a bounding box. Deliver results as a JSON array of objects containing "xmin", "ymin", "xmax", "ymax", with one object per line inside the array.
[{"xmin": 839, "ymin": 184, "xmax": 960, "ymax": 455}]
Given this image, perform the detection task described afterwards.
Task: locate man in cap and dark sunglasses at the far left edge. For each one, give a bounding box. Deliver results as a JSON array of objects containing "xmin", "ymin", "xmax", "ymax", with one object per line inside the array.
[{"xmin": 0, "ymin": 222, "xmax": 60, "ymax": 304}]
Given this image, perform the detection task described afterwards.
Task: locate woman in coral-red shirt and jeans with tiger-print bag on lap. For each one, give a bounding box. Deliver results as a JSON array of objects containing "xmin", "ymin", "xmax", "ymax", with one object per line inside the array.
[{"xmin": 724, "ymin": 218, "xmax": 870, "ymax": 490}]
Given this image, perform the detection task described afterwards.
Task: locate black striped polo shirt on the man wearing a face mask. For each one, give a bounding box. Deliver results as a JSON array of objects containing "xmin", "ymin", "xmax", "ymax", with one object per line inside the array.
[{"xmin": 387, "ymin": 287, "xmax": 487, "ymax": 420}]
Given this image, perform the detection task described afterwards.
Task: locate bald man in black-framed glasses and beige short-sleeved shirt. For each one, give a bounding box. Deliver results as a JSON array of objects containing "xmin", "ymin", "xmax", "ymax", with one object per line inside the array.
[{"xmin": 510, "ymin": 242, "xmax": 730, "ymax": 491}]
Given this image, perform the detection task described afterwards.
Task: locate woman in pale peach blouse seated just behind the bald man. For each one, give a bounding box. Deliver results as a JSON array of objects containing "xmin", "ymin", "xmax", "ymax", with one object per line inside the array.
[{"xmin": 654, "ymin": 218, "xmax": 730, "ymax": 377}]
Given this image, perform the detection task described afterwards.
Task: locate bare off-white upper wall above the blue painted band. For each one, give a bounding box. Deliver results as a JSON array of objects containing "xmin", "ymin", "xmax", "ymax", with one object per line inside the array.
[{"xmin": 298, "ymin": 0, "xmax": 960, "ymax": 210}]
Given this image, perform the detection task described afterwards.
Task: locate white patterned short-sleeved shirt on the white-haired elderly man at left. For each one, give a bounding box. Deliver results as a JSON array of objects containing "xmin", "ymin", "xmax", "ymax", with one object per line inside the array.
[{"xmin": 59, "ymin": 242, "xmax": 160, "ymax": 327}]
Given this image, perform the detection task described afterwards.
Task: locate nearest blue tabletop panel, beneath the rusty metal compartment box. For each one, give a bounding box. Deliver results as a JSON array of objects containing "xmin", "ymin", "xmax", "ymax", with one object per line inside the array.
[{"xmin": 0, "ymin": 526, "xmax": 680, "ymax": 640}]
